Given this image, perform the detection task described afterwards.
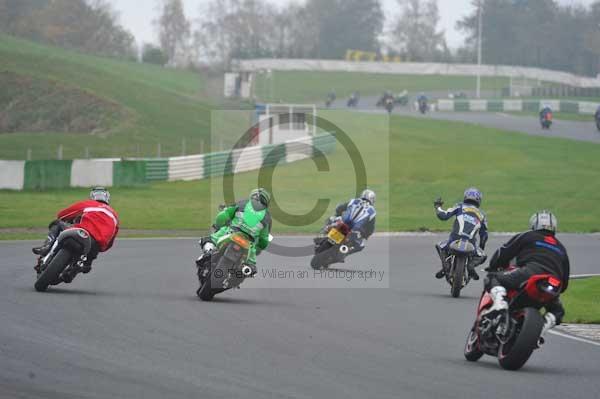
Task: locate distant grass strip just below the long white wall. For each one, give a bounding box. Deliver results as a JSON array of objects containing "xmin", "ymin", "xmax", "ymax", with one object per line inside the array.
[{"xmin": 256, "ymin": 71, "xmax": 509, "ymax": 103}]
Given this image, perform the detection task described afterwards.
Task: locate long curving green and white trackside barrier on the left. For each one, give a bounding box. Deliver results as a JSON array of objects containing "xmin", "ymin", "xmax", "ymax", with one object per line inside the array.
[{"xmin": 0, "ymin": 134, "xmax": 336, "ymax": 190}]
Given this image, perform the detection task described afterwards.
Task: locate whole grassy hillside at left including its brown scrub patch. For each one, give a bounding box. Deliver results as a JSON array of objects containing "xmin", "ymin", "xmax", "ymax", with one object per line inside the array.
[{"xmin": 0, "ymin": 35, "xmax": 210, "ymax": 159}]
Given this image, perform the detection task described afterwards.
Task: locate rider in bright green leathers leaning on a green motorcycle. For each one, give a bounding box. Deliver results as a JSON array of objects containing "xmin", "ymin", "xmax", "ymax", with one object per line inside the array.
[{"xmin": 198, "ymin": 188, "xmax": 271, "ymax": 271}]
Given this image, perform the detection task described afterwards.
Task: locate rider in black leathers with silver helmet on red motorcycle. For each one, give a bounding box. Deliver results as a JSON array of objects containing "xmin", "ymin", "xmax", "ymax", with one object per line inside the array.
[{"xmin": 485, "ymin": 211, "xmax": 570, "ymax": 335}]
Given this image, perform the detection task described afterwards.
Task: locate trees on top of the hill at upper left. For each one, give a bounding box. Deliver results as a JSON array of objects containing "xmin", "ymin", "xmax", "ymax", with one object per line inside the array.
[{"xmin": 0, "ymin": 0, "xmax": 137, "ymax": 59}]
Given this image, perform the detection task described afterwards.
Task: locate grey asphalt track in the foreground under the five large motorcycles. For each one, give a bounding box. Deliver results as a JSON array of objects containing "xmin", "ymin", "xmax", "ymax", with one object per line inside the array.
[{"xmin": 0, "ymin": 235, "xmax": 600, "ymax": 399}]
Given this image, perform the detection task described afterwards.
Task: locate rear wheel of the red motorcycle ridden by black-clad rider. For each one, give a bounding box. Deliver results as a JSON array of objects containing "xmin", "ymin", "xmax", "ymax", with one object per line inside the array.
[{"xmin": 498, "ymin": 308, "xmax": 544, "ymax": 370}]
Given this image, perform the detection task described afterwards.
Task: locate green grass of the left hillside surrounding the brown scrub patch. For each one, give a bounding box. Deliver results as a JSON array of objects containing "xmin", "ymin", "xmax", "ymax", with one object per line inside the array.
[{"xmin": 0, "ymin": 35, "xmax": 216, "ymax": 159}]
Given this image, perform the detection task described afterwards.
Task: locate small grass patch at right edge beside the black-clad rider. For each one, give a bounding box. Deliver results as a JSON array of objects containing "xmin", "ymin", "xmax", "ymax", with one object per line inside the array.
[{"xmin": 561, "ymin": 277, "xmax": 600, "ymax": 324}]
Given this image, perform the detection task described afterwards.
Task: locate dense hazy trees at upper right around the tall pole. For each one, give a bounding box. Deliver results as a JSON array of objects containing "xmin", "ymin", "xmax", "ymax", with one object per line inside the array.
[{"xmin": 457, "ymin": 0, "xmax": 600, "ymax": 76}]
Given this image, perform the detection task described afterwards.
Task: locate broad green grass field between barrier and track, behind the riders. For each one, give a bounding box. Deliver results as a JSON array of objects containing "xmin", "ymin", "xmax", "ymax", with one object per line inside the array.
[{"xmin": 0, "ymin": 111, "xmax": 600, "ymax": 234}]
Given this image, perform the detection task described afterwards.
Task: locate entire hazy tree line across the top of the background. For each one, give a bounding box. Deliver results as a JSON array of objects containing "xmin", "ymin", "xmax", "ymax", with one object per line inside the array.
[{"xmin": 0, "ymin": 0, "xmax": 600, "ymax": 76}]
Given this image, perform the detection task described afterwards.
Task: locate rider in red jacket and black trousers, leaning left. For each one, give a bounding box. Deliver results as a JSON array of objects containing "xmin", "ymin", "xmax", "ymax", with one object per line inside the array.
[{"xmin": 32, "ymin": 187, "xmax": 119, "ymax": 277}]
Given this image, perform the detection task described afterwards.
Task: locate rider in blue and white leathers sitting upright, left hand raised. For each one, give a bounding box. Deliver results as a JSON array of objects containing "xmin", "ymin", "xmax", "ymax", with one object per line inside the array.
[{"xmin": 433, "ymin": 187, "xmax": 488, "ymax": 280}]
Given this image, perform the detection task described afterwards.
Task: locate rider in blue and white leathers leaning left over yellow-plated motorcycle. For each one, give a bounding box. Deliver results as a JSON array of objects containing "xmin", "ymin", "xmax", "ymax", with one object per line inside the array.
[{"xmin": 325, "ymin": 189, "xmax": 377, "ymax": 253}]
